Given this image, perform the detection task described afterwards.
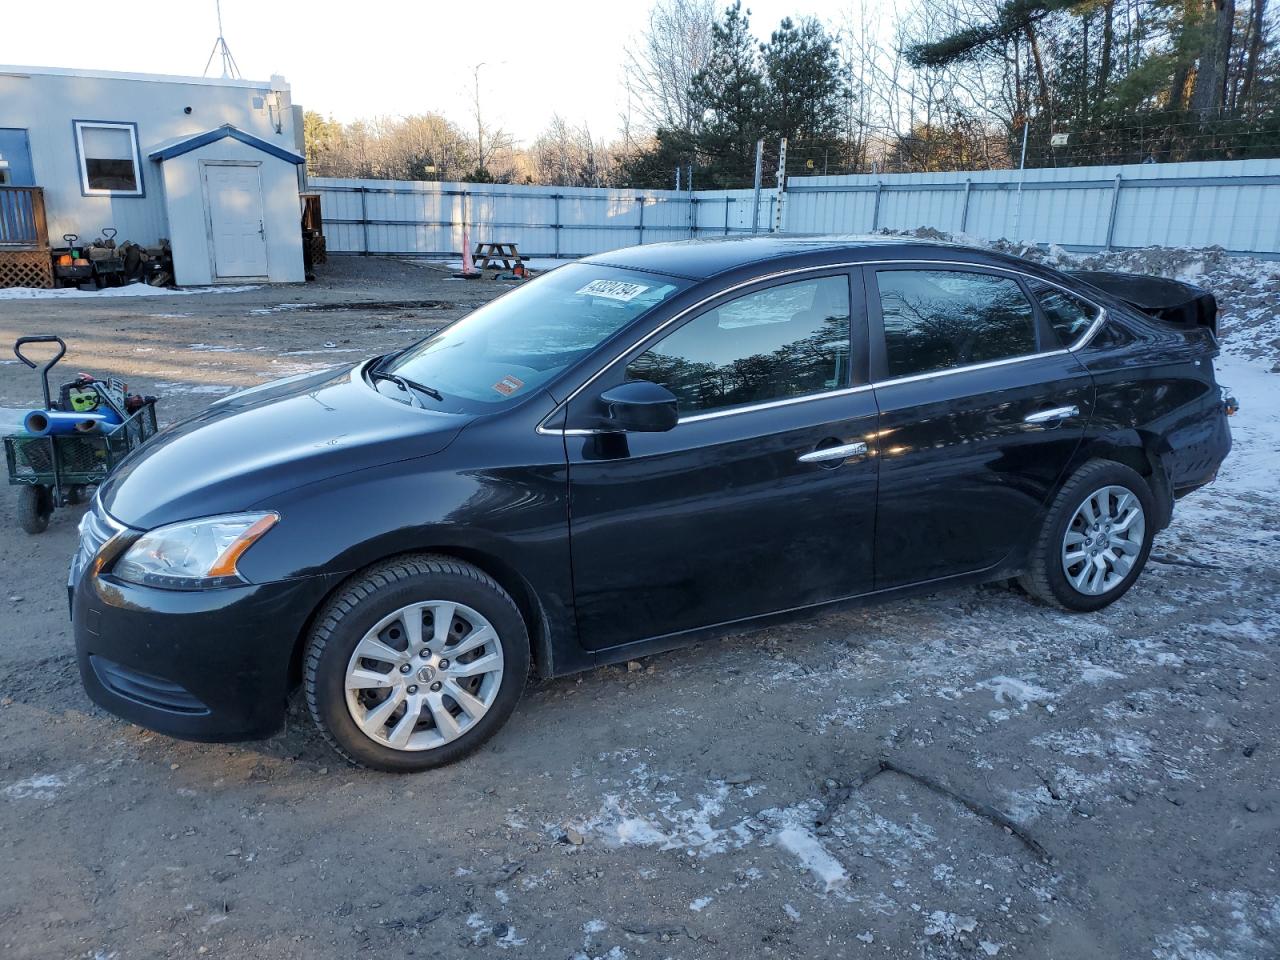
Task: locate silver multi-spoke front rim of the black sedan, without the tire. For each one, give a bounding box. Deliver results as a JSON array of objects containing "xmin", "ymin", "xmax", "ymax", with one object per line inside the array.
[{"xmin": 344, "ymin": 600, "xmax": 503, "ymax": 750}]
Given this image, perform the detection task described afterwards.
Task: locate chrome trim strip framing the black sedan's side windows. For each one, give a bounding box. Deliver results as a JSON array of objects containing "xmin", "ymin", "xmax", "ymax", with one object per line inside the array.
[{"xmin": 535, "ymin": 260, "xmax": 1107, "ymax": 436}]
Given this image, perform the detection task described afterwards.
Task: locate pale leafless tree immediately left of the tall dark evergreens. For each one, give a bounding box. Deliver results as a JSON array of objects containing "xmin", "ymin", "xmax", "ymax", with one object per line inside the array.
[{"xmin": 623, "ymin": 0, "xmax": 717, "ymax": 131}]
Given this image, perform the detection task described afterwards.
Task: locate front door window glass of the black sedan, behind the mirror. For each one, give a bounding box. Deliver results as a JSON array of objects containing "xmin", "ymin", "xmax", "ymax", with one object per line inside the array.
[{"xmin": 626, "ymin": 275, "xmax": 850, "ymax": 415}]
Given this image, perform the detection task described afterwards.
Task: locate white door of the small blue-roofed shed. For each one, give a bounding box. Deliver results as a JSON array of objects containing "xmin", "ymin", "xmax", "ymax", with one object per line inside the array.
[{"xmin": 205, "ymin": 164, "xmax": 266, "ymax": 280}]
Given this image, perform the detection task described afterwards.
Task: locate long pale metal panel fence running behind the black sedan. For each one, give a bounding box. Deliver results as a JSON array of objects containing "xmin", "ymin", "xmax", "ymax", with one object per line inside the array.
[{"xmin": 310, "ymin": 160, "xmax": 1280, "ymax": 257}]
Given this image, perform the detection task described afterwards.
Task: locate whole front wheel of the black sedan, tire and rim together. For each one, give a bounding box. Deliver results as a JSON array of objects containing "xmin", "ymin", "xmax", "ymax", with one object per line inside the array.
[{"xmin": 303, "ymin": 554, "xmax": 530, "ymax": 773}]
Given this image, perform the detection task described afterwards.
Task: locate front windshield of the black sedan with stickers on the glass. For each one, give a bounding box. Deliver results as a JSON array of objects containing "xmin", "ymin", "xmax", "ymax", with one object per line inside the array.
[{"xmin": 383, "ymin": 264, "xmax": 690, "ymax": 410}]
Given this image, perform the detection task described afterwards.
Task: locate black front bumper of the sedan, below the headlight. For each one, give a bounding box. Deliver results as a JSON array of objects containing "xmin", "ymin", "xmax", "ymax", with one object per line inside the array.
[{"xmin": 70, "ymin": 563, "xmax": 335, "ymax": 741}]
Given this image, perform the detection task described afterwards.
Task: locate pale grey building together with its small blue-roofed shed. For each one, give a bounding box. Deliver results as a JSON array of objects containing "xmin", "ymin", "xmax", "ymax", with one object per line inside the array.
[{"xmin": 0, "ymin": 67, "xmax": 303, "ymax": 284}]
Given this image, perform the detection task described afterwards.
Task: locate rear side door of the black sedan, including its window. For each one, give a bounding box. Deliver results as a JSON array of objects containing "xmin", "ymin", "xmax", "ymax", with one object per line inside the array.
[{"xmin": 864, "ymin": 264, "xmax": 1093, "ymax": 589}]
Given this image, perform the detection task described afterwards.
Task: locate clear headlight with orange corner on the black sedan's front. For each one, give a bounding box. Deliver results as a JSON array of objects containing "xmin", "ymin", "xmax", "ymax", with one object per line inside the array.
[{"xmin": 111, "ymin": 513, "xmax": 280, "ymax": 590}]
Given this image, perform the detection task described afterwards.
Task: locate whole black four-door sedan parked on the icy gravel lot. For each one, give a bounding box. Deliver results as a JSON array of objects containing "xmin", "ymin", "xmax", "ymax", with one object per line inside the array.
[{"xmin": 70, "ymin": 237, "xmax": 1230, "ymax": 771}]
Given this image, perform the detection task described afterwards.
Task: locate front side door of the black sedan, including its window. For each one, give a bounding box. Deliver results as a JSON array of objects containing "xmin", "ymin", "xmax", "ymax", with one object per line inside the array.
[{"xmin": 566, "ymin": 271, "xmax": 877, "ymax": 649}]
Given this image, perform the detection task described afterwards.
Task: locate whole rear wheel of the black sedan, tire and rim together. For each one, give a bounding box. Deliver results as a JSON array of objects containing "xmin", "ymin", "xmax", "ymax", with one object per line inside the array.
[{"xmin": 1018, "ymin": 460, "xmax": 1157, "ymax": 613}]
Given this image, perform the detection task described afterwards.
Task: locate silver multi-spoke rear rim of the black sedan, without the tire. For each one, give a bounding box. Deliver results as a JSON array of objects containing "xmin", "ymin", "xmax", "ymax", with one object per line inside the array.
[{"xmin": 1062, "ymin": 484, "xmax": 1147, "ymax": 596}]
